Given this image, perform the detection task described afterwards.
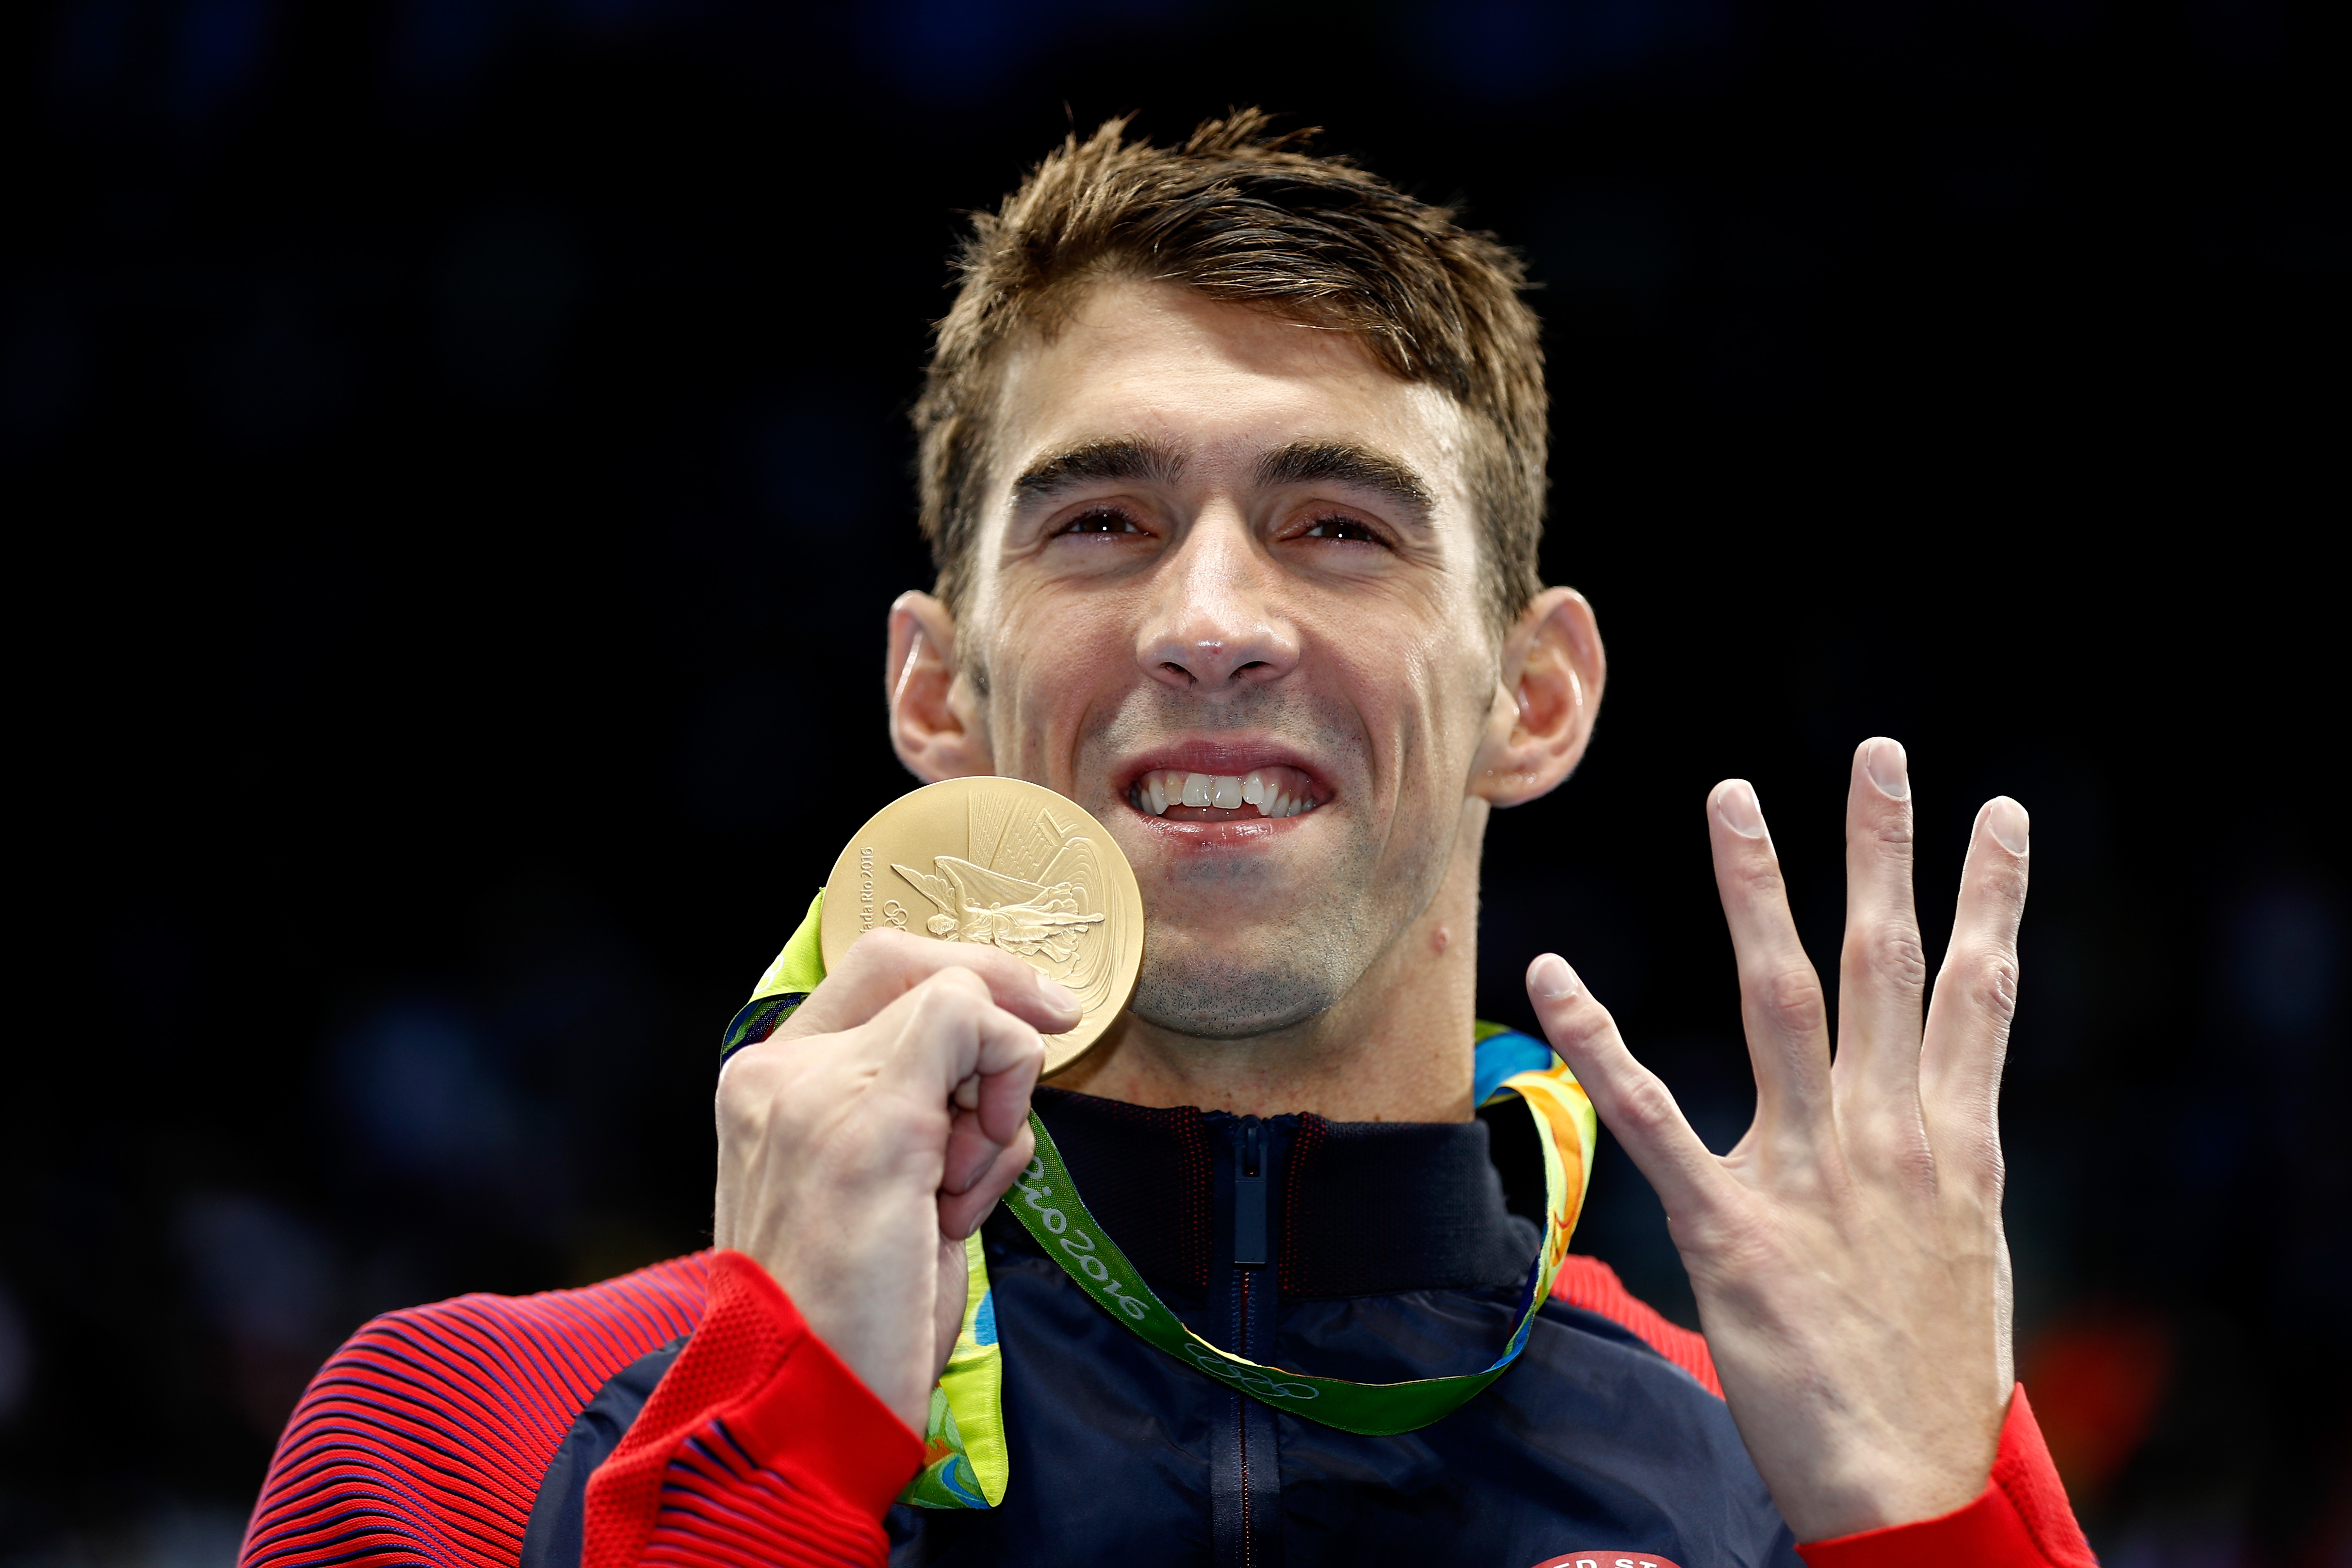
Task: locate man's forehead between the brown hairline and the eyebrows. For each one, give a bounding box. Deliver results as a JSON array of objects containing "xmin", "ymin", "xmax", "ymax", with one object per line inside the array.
[{"xmin": 992, "ymin": 282, "xmax": 1465, "ymax": 519}]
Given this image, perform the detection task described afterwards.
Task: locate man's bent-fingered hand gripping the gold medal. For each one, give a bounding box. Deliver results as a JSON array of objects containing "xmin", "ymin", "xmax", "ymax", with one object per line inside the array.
[{"xmin": 713, "ymin": 931, "xmax": 1077, "ymax": 1432}]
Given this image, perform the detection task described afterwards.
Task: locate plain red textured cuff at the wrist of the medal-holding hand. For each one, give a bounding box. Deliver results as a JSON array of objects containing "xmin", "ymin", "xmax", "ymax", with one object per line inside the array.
[{"xmin": 581, "ymin": 1251, "xmax": 922, "ymax": 1568}]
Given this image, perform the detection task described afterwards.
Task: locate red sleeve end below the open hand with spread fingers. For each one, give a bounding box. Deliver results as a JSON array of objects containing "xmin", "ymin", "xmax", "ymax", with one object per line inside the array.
[{"xmin": 1797, "ymin": 1385, "xmax": 2098, "ymax": 1568}]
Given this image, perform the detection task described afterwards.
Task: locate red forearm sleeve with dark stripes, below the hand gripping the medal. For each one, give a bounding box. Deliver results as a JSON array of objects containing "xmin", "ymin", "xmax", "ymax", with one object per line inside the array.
[{"xmin": 581, "ymin": 1253, "xmax": 922, "ymax": 1568}]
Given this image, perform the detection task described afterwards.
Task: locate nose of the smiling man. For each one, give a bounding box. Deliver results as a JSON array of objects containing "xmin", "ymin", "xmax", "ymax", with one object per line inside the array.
[{"xmin": 1136, "ymin": 515, "xmax": 1298, "ymax": 696}]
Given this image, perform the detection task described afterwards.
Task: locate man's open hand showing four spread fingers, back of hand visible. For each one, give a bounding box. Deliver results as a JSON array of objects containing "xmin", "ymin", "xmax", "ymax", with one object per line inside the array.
[{"xmin": 1526, "ymin": 738, "xmax": 2028, "ymax": 1540}]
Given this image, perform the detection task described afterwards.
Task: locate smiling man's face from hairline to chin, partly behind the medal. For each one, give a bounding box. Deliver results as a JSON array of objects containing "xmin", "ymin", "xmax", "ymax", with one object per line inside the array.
[{"xmin": 957, "ymin": 282, "xmax": 1498, "ymax": 1039}]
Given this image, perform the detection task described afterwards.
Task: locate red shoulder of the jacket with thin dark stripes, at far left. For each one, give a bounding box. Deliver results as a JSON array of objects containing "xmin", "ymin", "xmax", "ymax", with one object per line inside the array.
[{"xmin": 240, "ymin": 1255, "xmax": 710, "ymax": 1568}]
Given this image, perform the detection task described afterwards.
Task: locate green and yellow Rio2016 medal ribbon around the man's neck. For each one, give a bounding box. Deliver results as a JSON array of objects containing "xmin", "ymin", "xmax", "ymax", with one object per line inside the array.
[{"xmin": 722, "ymin": 893, "xmax": 1597, "ymax": 1507}]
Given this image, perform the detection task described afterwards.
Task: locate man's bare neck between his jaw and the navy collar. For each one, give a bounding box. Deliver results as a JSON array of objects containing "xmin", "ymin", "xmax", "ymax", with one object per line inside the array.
[{"xmin": 1054, "ymin": 799, "xmax": 1487, "ymax": 1121}]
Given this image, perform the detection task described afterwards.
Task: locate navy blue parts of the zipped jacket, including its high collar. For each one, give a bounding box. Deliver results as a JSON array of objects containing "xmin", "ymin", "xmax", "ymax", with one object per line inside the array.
[{"xmin": 522, "ymin": 1088, "xmax": 1799, "ymax": 1568}]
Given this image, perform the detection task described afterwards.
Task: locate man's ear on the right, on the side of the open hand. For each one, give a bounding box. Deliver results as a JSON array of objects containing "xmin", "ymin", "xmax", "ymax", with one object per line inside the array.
[{"xmin": 1470, "ymin": 588, "xmax": 1609, "ymax": 807}]
